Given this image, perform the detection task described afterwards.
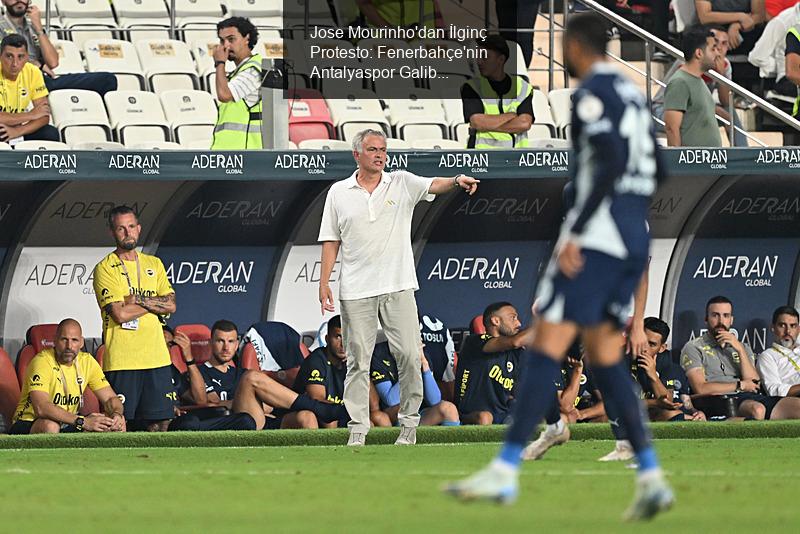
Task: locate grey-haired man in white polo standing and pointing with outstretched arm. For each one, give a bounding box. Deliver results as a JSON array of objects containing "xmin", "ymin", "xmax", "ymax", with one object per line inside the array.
[{"xmin": 319, "ymin": 130, "xmax": 478, "ymax": 446}]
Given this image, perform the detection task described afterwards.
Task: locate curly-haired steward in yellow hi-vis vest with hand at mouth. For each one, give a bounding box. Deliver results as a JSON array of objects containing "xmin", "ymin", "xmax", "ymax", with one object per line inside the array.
[{"xmin": 211, "ymin": 17, "xmax": 263, "ymax": 150}]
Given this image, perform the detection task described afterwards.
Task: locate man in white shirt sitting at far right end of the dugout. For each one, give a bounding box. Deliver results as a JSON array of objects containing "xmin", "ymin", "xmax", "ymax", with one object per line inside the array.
[{"xmin": 758, "ymin": 306, "xmax": 800, "ymax": 397}]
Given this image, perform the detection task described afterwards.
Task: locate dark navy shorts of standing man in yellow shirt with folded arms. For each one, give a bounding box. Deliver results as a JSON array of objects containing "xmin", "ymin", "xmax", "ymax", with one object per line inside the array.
[{"xmin": 106, "ymin": 365, "xmax": 177, "ymax": 421}]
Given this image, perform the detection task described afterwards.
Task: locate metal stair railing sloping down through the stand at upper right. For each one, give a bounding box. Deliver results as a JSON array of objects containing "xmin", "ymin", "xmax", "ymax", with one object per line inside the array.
[{"xmin": 577, "ymin": 0, "xmax": 800, "ymax": 146}]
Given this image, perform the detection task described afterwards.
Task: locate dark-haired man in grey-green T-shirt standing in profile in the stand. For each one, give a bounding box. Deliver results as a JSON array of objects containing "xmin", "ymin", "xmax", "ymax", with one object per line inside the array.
[{"xmin": 664, "ymin": 27, "xmax": 722, "ymax": 147}]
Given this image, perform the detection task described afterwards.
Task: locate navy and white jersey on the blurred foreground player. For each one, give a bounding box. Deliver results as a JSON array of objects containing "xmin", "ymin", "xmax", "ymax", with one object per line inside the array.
[{"xmin": 562, "ymin": 63, "xmax": 662, "ymax": 259}]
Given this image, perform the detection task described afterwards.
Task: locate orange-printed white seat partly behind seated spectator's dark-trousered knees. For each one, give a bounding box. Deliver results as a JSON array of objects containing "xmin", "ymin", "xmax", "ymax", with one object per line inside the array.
[{"xmin": 83, "ymin": 39, "xmax": 147, "ymax": 91}]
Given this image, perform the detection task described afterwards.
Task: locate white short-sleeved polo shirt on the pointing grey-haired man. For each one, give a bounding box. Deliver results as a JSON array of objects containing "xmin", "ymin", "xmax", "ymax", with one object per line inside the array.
[{"xmin": 319, "ymin": 171, "xmax": 435, "ymax": 300}]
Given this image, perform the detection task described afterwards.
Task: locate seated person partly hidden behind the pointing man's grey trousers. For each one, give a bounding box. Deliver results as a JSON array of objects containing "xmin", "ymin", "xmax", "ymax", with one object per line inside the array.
[{"xmin": 370, "ymin": 342, "xmax": 461, "ymax": 426}]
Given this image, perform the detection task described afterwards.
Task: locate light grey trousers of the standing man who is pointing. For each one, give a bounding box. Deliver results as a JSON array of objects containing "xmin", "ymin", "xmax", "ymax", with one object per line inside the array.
[{"xmin": 341, "ymin": 289, "xmax": 422, "ymax": 434}]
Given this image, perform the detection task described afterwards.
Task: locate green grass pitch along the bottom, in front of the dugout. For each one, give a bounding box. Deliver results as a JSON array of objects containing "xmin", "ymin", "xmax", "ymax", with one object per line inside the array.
[{"xmin": 0, "ymin": 430, "xmax": 800, "ymax": 534}]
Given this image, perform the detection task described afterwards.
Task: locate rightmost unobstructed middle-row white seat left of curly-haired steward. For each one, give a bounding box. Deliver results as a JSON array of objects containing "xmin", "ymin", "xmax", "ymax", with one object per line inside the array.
[{"xmin": 136, "ymin": 39, "xmax": 200, "ymax": 93}]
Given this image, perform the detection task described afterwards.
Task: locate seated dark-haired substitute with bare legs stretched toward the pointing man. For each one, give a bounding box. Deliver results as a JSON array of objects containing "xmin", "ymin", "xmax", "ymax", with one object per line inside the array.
[{"xmin": 176, "ymin": 319, "xmax": 343, "ymax": 429}]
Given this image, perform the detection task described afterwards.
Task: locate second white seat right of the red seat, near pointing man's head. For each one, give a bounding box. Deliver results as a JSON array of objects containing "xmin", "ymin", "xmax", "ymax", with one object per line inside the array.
[{"xmin": 385, "ymin": 89, "xmax": 447, "ymax": 139}]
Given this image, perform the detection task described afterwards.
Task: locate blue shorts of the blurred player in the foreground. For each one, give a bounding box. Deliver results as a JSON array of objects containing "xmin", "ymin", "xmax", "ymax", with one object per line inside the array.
[{"xmin": 536, "ymin": 250, "xmax": 647, "ymax": 329}]
